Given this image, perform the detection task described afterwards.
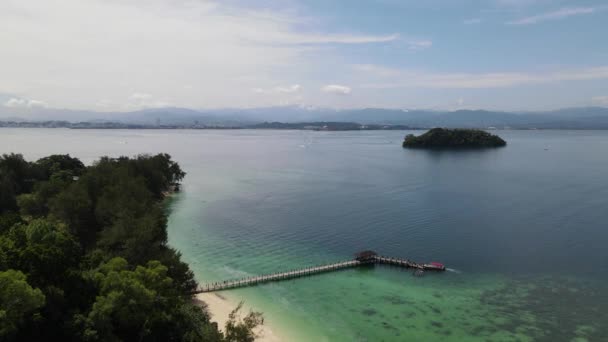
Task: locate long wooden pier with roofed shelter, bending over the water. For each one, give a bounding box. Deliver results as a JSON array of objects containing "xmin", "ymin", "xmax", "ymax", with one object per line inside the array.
[{"xmin": 195, "ymin": 251, "xmax": 445, "ymax": 293}]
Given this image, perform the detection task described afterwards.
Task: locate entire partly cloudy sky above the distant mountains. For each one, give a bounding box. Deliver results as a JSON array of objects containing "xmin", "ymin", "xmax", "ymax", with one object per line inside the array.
[{"xmin": 0, "ymin": 0, "xmax": 608, "ymax": 111}]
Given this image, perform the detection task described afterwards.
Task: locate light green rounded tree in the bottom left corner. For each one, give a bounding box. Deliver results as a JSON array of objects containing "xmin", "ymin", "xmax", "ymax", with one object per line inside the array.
[{"xmin": 0, "ymin": 270, "xmax": 45, "ymax": 340}]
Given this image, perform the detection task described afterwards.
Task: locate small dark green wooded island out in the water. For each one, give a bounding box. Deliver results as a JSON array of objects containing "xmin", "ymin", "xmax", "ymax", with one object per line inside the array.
[{"xmin": 403, "ymin": 128, "xmax": 507, "ymax": 148}]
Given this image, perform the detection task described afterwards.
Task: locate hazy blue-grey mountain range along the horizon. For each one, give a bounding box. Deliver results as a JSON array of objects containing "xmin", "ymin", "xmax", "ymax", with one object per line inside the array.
[{"xmin": 0, "ymin": 106, "xmax": 608, "ymax": 129}]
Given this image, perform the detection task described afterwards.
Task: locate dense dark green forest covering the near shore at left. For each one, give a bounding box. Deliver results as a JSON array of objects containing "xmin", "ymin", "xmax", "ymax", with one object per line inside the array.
[{"xmin": 0, "ymin": 154, "xmax": 262, "ymax": 341}]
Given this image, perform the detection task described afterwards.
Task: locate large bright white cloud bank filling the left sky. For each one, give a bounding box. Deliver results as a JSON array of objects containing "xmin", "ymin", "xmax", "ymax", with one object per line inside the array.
[{"xmin": 0, "ymin": 0, "xmax": 396, "ymax": 110}]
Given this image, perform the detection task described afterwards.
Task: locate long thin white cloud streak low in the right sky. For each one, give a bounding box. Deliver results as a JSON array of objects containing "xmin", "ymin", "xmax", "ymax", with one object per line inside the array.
[{"xmin": 353, "ymin": 65, "xmax": 608, "ymax": 89}]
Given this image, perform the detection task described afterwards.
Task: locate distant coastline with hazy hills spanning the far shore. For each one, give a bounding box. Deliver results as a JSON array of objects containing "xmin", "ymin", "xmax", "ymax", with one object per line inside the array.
[{"xmin": 0, "ymin": 106, "xmax": 608, "ymax": 130}]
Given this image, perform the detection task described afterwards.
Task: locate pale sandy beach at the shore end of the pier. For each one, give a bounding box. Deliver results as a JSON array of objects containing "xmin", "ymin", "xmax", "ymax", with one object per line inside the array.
[{"xmin": 196, "ymin": 293, "xmax": 289, "ymax": 342}]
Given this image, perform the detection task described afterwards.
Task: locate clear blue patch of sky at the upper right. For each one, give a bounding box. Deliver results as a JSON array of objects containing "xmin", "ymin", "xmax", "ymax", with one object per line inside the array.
[{"xmin": 296, "ymin": 0, "xmax": 608, "ymax": 72}]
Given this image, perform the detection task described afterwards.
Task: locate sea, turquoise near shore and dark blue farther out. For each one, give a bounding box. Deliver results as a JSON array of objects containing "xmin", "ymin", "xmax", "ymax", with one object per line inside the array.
[{"xmin": 0, "ymin": 130, "xmax": 608, "ymax": 341}]
